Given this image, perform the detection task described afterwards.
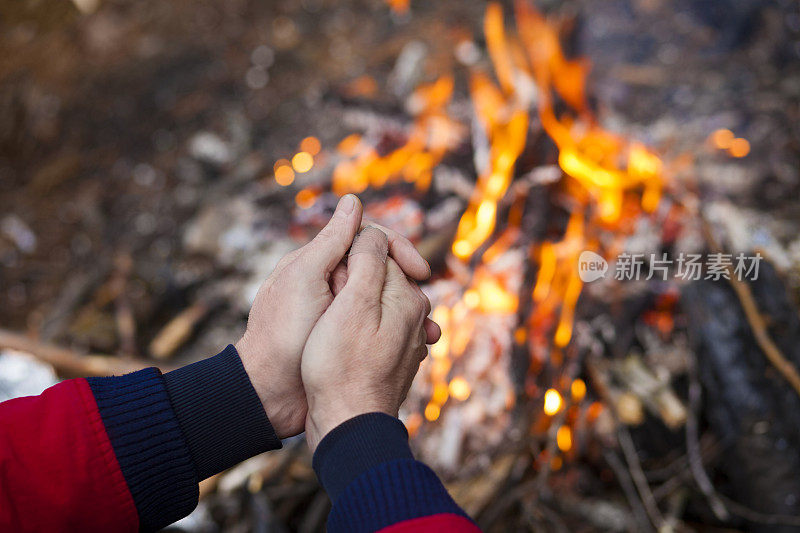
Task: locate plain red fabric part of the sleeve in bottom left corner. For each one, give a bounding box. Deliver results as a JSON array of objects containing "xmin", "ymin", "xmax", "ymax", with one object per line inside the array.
[{"xmin": 0, "ymin": 379, "xmax": 139, "ymax": 532}]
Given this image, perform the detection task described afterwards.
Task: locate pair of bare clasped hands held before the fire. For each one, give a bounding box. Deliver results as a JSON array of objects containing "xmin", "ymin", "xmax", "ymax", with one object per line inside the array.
[{"xmin": 236, "ymin": 195, "xmax": 441, "ymax": 450}]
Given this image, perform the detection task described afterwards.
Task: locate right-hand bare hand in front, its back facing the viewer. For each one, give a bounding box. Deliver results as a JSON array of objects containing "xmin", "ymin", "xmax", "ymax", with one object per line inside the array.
[{"xmin": 301, "ymin": 226, "xmax": 440, "ymax": 450}]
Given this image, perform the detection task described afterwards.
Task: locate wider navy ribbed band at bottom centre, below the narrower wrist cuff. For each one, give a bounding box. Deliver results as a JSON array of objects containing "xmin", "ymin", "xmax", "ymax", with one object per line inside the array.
[{"xmin": 327, "ymin": 459, "xmax": 469, "ymax": 533}]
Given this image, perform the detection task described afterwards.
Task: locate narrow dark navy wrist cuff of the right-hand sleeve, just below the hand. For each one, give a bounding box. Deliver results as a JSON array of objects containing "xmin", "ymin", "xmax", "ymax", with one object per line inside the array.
[{"xmin": 312, "ymin": 413, "xmax": 414, "ymax": 502}]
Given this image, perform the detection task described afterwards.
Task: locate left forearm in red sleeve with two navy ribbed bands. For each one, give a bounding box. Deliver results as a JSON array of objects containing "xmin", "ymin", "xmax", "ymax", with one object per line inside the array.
[{"xmin": 0, "ymin": 346, "xmax": 280, "ymax": 531}]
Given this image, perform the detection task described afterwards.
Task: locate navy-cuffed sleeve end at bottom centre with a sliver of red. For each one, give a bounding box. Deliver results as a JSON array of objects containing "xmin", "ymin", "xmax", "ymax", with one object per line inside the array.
[{"xmin": 313, "ymin": 413, "xmax": 478, "ymax": 532}]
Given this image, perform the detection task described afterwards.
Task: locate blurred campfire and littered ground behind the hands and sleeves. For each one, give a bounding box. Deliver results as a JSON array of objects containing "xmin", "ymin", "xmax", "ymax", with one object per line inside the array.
[{"xmin": 0, "ymin": 0, "xmax": 800, "ymax": 531}]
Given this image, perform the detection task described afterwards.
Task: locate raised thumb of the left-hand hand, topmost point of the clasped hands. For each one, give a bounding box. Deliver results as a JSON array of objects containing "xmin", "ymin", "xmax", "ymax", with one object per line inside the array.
[{"xmin": 302, "ymin": 194, "xmax": 363, "ymax": 276}]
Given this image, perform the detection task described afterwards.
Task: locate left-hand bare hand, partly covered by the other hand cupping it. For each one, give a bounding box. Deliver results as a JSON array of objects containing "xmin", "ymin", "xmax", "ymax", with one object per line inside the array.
[{"xmin": 236, "ymin": 194, "xmax": 438, "ymax": 438}]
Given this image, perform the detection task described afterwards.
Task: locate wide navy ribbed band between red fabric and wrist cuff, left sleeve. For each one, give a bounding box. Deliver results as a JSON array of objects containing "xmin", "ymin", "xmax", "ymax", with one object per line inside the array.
[{"xmin": 87, "ymin": 368, "xmax": 198, "ymax": 531}]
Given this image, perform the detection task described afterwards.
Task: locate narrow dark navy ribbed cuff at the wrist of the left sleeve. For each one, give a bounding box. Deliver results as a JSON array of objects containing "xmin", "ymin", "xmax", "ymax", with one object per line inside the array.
[{"xmin": 164, "ymin": 344, "xmax": 281, "ymax": 480}]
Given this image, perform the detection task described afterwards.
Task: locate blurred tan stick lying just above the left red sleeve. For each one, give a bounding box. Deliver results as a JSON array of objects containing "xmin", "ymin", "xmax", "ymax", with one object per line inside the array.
[{"xmin": 0, "ymin": 329, "xmax": 167, "ymax": 377}]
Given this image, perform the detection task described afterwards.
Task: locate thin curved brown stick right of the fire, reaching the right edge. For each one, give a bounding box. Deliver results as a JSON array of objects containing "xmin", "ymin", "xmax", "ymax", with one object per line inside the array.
[{"xmin": 701, "ymin": 215, "xmax": 800, "ymax": 395}]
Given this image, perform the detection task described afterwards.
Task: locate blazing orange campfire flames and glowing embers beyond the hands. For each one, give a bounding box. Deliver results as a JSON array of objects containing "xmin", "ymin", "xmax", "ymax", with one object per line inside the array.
[{"xmin": 274, "ymin": 1, "xmax": 667, "ymax": 469}]
